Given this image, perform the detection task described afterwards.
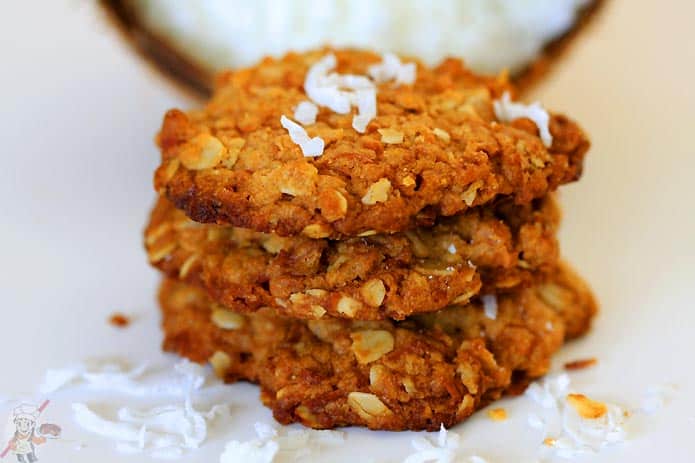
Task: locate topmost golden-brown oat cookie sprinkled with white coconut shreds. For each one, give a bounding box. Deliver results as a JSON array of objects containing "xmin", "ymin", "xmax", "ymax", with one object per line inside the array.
[{"xmin": 155, "ymin": 50, "xmax": 589, "ymax": 238}]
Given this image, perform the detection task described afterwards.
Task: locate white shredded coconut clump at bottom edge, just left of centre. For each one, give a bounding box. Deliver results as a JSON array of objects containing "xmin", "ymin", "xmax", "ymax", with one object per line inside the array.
[{"xmin": 220, "ymin": 423, "xmax": 345, "ymax": 463}]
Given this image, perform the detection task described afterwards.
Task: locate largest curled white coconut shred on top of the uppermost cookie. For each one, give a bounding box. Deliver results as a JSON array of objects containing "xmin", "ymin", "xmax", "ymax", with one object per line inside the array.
[{"xmin": 304, "ymin": 54, "xmax": 376, "ymax": 133}]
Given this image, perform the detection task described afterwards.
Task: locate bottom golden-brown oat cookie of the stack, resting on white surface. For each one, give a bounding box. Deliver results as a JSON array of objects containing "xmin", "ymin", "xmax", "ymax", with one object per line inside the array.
[{"xmin": 160, "ymin": 262, "xmax": 595, "ymax": 430}]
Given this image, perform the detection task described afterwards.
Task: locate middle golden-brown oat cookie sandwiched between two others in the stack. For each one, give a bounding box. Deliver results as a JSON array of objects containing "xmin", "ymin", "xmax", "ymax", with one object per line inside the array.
[{"xmin": 145, "ymin": 196, "xmax": 560, "ymax": 320}]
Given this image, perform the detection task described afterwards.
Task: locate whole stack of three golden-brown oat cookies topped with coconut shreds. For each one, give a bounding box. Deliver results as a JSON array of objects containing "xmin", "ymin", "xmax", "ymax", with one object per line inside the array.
[{"xmin": 145, "ymin": 50, "xmax": 596, "ymax": 430}]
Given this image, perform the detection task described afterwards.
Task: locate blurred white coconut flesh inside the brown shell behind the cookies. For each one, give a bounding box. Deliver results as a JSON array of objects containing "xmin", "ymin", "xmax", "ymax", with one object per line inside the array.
[{"xmin": 129, "ymin": 0, "xmax": 590, "ymax": 74}]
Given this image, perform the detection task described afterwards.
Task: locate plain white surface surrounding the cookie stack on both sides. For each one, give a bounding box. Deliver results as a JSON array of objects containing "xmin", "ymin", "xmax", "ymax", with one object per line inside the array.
[{"xmin": 0, "ymin": 0, "xmax": 695, "ymax": 463}]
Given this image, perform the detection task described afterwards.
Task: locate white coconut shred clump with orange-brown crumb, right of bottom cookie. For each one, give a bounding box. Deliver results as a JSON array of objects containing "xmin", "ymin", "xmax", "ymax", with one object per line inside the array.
[{"xmin": 526, "ymin": 373, "xmax": 629, "ymax": 458}]
